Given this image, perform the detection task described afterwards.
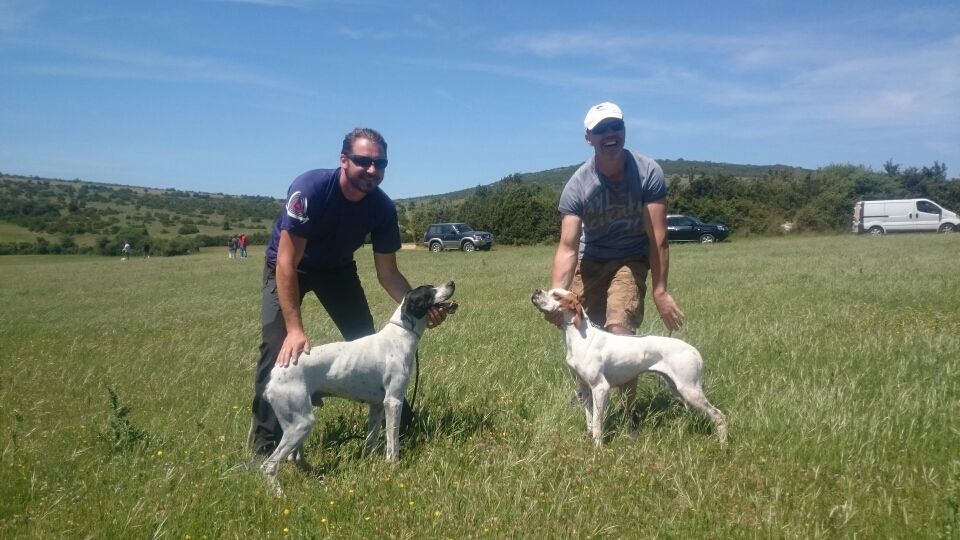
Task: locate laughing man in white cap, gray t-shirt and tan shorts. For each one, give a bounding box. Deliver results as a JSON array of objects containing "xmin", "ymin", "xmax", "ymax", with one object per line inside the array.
[{"xmin": 550, "ymin": 102, "xmax": 684, "ymax": 340}]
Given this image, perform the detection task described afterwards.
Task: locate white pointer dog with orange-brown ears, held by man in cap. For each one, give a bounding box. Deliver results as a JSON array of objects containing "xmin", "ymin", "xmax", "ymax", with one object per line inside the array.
[{"xmin": 530, "ymin": 289, "xmax": 727, "ymax": 446}]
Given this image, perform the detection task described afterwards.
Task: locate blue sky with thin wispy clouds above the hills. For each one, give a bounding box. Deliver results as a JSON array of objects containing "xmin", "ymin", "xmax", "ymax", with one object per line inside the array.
[{"xmin": 0, "ymin": 0, "xmax": 960, "ymax": 198}]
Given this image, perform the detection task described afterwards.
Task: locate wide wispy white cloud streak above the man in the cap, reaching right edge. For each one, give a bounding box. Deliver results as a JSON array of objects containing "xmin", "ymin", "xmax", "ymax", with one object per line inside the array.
[{"xmin": 496, "ymin": 24, "xmax": 960, "ymax": 130}]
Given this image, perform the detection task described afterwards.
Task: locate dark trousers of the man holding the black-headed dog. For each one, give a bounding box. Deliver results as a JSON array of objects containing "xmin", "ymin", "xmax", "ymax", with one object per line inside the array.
[{"xmin": 253, "ymin": 262, "xmax": 374, "ymax": 454}]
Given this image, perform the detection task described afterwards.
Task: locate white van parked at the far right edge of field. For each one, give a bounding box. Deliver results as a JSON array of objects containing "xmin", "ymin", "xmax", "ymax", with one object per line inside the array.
[{"xmin": 853, "ymin": 199, "xmax": 960, "ymax": 234}]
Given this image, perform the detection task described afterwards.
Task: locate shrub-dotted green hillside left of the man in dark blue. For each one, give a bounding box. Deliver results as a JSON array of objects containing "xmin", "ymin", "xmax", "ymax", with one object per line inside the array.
[{"xmin": 0, "ymin": 175, "xmax": 283, "ymax": 254}]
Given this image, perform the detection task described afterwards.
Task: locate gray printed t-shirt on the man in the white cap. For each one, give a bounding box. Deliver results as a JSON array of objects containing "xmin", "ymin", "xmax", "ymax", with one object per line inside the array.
[{"xmin": 559, "ymin": 151, "xmax": 667, "ymax": 261}]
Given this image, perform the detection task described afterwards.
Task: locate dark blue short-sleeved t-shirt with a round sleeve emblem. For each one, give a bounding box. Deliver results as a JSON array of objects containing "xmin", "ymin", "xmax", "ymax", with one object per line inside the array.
[{"xmin": 266, "ymin": 169, "xmax": 400, "ymax": 270}]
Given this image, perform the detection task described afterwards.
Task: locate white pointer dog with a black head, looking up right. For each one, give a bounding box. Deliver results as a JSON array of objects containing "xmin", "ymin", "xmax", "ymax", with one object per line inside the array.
[{"xmin": 260, "ymin": 281, "xmax": 457, "ymax": 493}]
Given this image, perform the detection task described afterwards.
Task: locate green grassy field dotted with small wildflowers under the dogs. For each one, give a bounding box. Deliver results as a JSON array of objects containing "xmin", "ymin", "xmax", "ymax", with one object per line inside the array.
[{"xmin": 0, "ymin": 235, "xmax": 960, "ymax": 539}]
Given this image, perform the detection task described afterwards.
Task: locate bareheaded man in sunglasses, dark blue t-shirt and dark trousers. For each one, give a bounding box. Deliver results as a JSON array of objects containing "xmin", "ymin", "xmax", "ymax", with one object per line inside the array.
[{"xmin": 246, "ymin": 128, "xmax": 446, "ymax": 456}]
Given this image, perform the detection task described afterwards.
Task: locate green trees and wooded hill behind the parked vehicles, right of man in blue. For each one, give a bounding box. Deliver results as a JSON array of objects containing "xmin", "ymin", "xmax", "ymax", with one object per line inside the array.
[{"xmin": 398, "ymin": 160, "xmax": 960, "ymax": 245}]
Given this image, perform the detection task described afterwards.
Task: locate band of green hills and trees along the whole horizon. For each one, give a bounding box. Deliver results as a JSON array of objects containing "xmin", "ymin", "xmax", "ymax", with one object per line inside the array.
[{"xmin": 0, "ymin": 160, "xmax": 960, "ymax": 255}]
